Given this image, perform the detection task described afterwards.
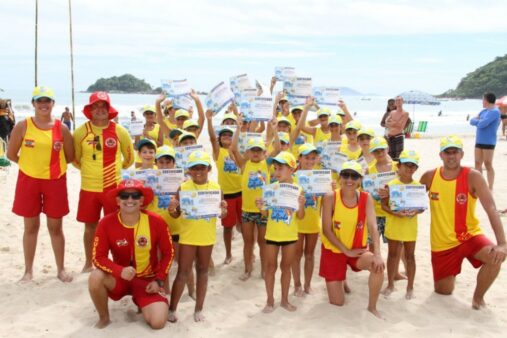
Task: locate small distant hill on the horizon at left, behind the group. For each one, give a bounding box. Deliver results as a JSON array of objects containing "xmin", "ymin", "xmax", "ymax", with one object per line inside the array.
[{"xmin": 86, "ymin": 74, "xmax": 157, "ymax": 93}]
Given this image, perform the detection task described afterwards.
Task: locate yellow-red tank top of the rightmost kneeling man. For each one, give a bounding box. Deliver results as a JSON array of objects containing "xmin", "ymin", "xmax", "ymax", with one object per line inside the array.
[{"xmin": 429, "ymin": 168, "xmax": 482, "ymax": 251}]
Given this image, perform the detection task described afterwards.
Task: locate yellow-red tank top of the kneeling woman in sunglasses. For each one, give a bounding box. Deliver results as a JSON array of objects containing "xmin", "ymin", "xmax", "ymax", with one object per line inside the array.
[{"xmin": 320, "ymin": 189, "xmax": 368, "ymax": 253}]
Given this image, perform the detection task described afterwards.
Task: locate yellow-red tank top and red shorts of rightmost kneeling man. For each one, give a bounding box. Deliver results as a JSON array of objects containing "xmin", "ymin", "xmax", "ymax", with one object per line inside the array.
[{"xmin": 429, "ymin": 167, "xmax": 493, "ymax": 281}]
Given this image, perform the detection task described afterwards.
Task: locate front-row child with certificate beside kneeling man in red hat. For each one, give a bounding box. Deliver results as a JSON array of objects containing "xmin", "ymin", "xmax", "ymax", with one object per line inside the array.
[{"xmin": 168, "ymin": 151, "xmax": 227, "ymax": 322}]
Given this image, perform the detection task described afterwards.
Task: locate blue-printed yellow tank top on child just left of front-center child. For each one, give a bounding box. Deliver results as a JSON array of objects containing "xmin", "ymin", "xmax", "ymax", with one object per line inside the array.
[{"xmin": 241, "ymin": 160, "xmax": 269, "ymax": 212}]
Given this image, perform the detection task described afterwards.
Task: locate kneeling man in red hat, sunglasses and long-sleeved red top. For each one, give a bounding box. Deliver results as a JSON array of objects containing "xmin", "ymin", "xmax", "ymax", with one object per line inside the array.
[{"xmin": 88, "ymin": 180, "xmax": 174, "ymax": 329}]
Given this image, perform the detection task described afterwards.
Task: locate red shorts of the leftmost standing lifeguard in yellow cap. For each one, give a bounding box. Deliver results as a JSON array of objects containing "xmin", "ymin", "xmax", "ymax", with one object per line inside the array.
[{"xmin": 12, "ymin": 170, "xmax": 69, "ymax": 218}]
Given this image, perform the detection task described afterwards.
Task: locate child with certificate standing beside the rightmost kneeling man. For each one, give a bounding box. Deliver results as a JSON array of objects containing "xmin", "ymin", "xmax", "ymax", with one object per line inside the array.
[{"xmin": 382, "ymin": 150, "xmax": 422, "ymax": 299}]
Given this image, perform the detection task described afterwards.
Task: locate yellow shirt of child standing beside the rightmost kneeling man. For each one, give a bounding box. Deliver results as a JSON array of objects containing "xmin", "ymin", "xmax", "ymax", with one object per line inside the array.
[{"xmin": 385, "ymin": 178, "xmax": 420, "ymax": 242}]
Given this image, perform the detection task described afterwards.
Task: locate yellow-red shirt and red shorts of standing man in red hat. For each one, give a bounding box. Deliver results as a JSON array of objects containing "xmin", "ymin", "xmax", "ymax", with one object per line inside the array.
[{"xmin": 74, "ymin": 121, "xmax": 134, "ymax": 223}]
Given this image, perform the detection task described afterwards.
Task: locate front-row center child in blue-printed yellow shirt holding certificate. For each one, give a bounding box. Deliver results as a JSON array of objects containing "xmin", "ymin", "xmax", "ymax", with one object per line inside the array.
[{"xmin": 255, "ymin": 151, "xmax": 305, "ymax": 313}]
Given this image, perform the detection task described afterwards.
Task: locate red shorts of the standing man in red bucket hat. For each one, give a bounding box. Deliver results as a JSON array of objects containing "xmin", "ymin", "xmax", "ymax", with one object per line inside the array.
[{"xmin": 77, "ymin": 190, "xmax": 118, "ymax": 223}]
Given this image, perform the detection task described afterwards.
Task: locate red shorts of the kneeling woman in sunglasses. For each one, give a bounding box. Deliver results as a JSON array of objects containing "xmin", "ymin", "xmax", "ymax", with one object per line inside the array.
[{"xmin": 319, "ymin": 245, "xmax": 361, "ymax": 282}]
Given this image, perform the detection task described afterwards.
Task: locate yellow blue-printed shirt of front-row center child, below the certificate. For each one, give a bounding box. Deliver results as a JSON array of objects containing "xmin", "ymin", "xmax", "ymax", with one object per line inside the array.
[{"xmin": 265, "ymin": 183, "xmax": 302, "ymax": 242}]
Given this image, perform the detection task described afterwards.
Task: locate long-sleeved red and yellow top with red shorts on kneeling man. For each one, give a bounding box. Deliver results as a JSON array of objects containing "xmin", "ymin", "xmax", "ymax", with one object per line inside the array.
[{"xmin": 92, "ymin": 212, "xmax": 174, "ymax": 308}]
